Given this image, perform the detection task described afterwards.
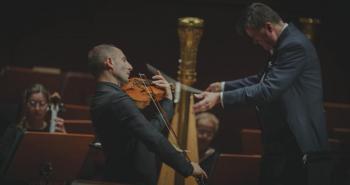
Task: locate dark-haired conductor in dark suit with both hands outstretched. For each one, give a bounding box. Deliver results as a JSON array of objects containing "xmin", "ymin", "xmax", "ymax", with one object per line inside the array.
[{"xmin": 194, "ymin": 3, "xmax": 330, "ymax": 185}]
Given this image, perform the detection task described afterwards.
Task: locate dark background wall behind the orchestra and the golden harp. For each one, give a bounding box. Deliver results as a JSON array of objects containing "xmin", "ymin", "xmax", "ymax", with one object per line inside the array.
[{"xmin": 0, "ymin": 0, "xmax": 350, "ymax": 152}]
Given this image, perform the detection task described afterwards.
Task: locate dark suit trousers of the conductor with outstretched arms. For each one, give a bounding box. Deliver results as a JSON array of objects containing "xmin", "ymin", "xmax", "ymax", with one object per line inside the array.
[{"xmin": 260, "ymin": 154, "xmax": 332, "ymax": 185}]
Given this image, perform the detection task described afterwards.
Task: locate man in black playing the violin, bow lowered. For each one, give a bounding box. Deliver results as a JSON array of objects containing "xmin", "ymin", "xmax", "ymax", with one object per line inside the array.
[{"xmin": 88, "ymin": 44, "xmax": 206, "ymax": 185}]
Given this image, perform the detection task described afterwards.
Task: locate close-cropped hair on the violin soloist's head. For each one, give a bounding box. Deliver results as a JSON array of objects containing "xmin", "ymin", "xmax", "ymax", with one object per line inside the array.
[{"xmin": 88, "ymin": 44, "xmax": 123, "ymax": 77}]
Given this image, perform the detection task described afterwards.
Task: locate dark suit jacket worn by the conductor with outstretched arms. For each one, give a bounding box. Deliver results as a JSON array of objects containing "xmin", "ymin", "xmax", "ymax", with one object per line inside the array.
[{"xmin": 223, "ymin": 24, "xmax": 329, "ymax": 153}]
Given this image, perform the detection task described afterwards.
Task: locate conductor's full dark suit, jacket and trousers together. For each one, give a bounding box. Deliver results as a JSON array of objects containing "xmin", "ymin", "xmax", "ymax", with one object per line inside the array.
[{"xmin": 223, "ymin": 24, "xmax": 330, "ymax": 185}]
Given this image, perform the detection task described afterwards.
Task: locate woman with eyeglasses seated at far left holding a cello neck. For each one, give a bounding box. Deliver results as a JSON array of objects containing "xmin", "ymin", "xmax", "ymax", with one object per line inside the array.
[{"xmin": 0, "ymin": 84, "xmax": 66, "ymax": 179}]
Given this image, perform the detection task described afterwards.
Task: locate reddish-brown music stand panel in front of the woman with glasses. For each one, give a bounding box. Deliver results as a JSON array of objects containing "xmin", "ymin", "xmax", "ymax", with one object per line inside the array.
[{"xmin": 7, "ymin": 132, "xmax": 94, "ymax": 182}]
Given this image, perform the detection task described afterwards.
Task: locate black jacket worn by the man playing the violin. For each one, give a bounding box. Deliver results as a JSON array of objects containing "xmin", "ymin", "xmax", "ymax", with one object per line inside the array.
[{"xmin": 91, "ymin": 82, "xmax": 193, "ymax": 185}]
